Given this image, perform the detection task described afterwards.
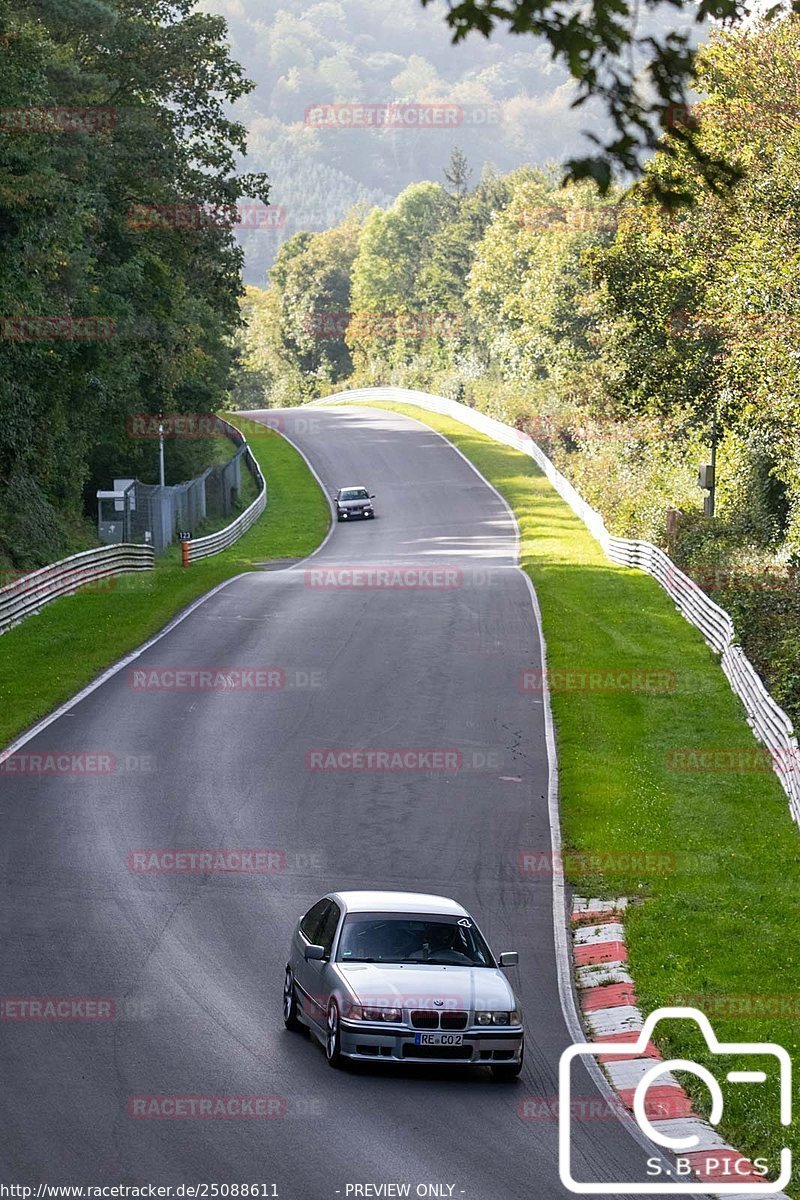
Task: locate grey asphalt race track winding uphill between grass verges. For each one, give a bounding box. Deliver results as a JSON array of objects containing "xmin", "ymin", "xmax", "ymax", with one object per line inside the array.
[{"xmin": 0, "ymin": 407, "xmax": 681, "ymax": 1200}]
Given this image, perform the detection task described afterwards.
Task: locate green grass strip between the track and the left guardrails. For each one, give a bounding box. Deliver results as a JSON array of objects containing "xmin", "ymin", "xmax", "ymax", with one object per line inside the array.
[{"xmin": 0, "ymin": 416, "xmax": 330, "ymax": 746}]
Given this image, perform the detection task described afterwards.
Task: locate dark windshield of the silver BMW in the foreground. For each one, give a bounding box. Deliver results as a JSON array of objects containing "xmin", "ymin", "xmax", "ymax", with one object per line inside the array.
[{"xmin": 336, "ymin": 912, "xmax": 495, "ymax": 967}]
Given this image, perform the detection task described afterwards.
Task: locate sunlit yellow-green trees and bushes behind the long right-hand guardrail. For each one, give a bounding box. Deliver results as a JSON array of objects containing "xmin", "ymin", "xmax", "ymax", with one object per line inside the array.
[{"xmin": 239, "ymin": 17, "xmax": 800, "ymax": 721}]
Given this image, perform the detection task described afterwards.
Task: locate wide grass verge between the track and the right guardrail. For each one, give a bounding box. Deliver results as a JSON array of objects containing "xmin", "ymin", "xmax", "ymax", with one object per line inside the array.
[{"xmin": 357, "ymin": 404, "xmax": 800, "ymax": 1195}]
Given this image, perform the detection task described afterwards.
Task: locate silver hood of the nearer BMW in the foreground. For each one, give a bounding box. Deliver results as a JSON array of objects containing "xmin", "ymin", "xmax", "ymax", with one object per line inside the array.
[{"xmin": 336, "ymin": 962, "xmax": 516, "ymax": 1013}]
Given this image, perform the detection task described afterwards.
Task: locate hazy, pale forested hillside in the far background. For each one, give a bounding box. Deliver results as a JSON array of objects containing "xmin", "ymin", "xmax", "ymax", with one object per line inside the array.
[{"xmin": 195, "ymin": 0, "xmax": 691, "ymax": 286}]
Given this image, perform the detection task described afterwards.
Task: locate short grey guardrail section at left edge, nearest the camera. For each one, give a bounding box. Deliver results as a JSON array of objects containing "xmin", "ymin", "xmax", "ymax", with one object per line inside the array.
[{"xmin": 0, "ymin": 544, "xmax": 155, "ymax": 634}]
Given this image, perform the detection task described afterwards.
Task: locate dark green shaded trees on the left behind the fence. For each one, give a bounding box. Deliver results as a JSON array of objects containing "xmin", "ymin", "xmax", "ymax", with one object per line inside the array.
[{"xmin": 0, "ymin": 0, "xmax": 267, "ymax": 569}]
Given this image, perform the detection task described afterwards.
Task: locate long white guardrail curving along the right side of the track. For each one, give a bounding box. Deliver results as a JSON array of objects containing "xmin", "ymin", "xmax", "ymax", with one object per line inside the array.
[{"xmin": 313, "ymin": 388, "xmax": 800, "ymax": 824}]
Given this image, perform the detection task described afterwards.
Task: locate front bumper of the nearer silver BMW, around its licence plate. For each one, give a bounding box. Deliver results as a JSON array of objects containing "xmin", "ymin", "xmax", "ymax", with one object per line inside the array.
[{"xmin": 339, "ymin": 1020, "xmax": 523, "ymax": 1067}]
